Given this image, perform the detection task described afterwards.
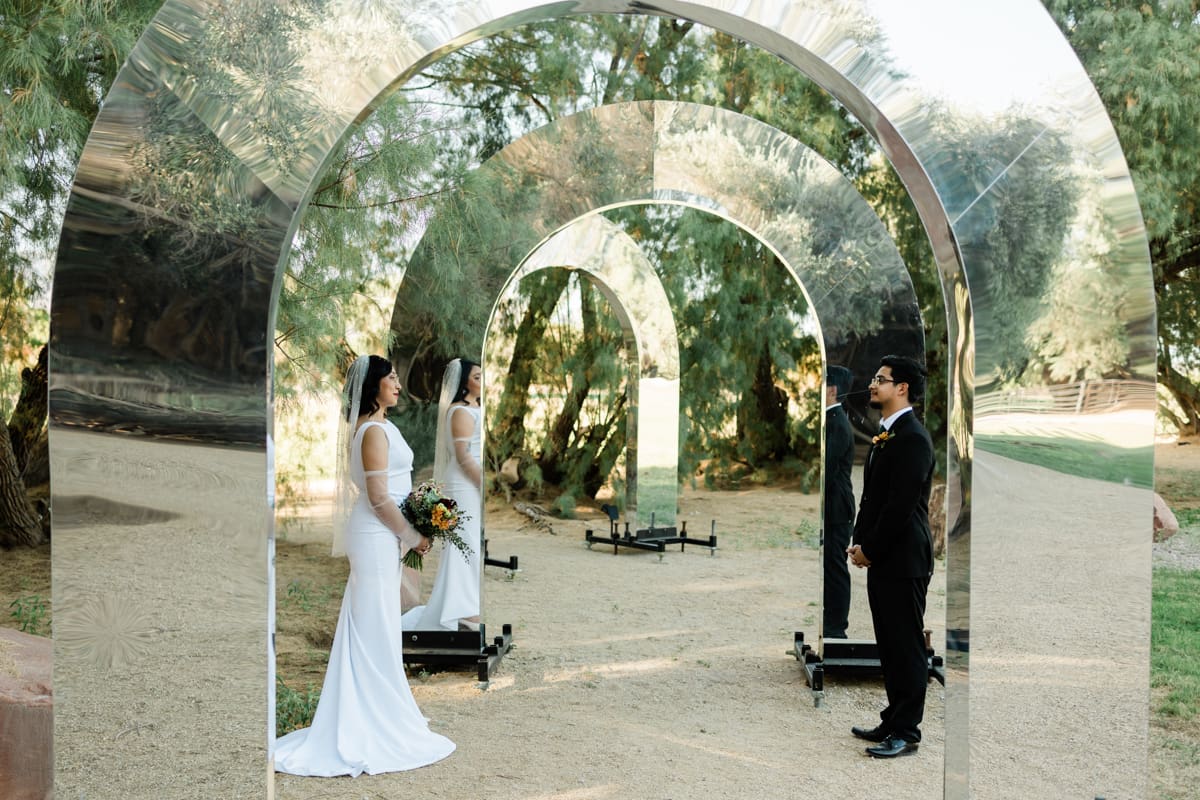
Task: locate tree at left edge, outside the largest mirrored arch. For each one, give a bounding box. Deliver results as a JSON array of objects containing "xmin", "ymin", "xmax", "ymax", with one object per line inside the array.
[{"xmin": 0, "ymin": 0, "xmax": 160, "ymax": 547}]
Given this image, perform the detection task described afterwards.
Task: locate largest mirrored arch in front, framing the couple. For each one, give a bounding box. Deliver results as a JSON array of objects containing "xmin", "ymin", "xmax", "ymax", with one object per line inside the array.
[{"xmin": 50, "ymin": 0, "xmax": 1154, "ymax": 798}]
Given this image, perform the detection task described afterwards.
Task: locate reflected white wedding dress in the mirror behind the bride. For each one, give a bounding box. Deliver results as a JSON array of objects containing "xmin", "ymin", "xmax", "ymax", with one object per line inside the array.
[{"xmin": 404, "ymin": 405, "xmax": 482, "ymax": 631}]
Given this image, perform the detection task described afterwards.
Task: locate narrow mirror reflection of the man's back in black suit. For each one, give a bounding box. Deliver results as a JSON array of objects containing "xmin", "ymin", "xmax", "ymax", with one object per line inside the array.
[{"xmin": 821, "ymin": 365, "xmax": 854, "ymax": 639}]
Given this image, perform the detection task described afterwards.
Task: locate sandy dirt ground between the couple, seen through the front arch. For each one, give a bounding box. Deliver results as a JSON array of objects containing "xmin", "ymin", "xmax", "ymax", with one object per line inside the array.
[{"xmin": 276, "ymin": 482, "xmax": 944, "ymax": 800}]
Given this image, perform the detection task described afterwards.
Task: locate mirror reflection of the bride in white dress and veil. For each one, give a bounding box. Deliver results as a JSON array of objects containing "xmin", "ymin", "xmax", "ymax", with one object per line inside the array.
[{"xmin": 404, "ymin": 359, "xmax": 484, "ymax": 631}]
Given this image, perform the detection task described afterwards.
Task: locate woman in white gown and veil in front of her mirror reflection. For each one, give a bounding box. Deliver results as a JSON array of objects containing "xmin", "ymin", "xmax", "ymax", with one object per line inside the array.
[{"xmin": 275, "ymin": 355, "xmax": 455, "ymax": 776}]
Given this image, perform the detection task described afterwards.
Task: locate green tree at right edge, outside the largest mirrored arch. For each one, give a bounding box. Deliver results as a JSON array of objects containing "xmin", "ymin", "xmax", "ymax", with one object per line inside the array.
[{"xmin": 1045, "ymin": 0, "xmax": 1200, "ymax": 435}]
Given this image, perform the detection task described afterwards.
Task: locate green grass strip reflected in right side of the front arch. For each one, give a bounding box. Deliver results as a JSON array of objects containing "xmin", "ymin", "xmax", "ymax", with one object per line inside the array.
[{"xmin": 976, "ymin": 435, "xmax": 1154, "ymax": 488}]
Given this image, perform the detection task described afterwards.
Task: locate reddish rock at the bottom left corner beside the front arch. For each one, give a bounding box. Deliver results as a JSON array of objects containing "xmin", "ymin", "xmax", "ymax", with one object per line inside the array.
[{"xmin": 0, "ymin": 628, "xmax": 54, "ymax": 800}]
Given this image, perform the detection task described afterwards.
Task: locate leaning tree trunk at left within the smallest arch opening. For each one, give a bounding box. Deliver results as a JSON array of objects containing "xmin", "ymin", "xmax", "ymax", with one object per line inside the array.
[{"xmin": 487, "ymin": 270, "xmax": 570, "ymax": 464}]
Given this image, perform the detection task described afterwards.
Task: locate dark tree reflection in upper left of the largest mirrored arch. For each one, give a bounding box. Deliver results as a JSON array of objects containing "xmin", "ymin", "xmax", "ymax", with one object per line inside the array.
[{"xmin": 54, "ymin": 4, "xmax": 340, "ymax": 407}]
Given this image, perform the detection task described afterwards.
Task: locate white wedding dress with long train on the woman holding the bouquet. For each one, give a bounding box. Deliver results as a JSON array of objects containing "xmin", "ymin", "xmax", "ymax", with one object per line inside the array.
[{"xmin": 275, "ymin": 422, "xmax": 455, "ymax": 776}]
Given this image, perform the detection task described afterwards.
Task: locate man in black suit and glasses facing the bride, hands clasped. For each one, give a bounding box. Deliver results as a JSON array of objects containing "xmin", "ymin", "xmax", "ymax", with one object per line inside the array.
[{"xmin": 846, "ymin": 355, "xmax": 934, "ymax": 758}]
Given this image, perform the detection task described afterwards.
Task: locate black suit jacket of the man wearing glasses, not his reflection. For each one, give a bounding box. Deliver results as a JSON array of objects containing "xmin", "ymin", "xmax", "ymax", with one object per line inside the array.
[{"xmin": 853, "ymin": 411, "xmax": 934, "ymax": 578}]
